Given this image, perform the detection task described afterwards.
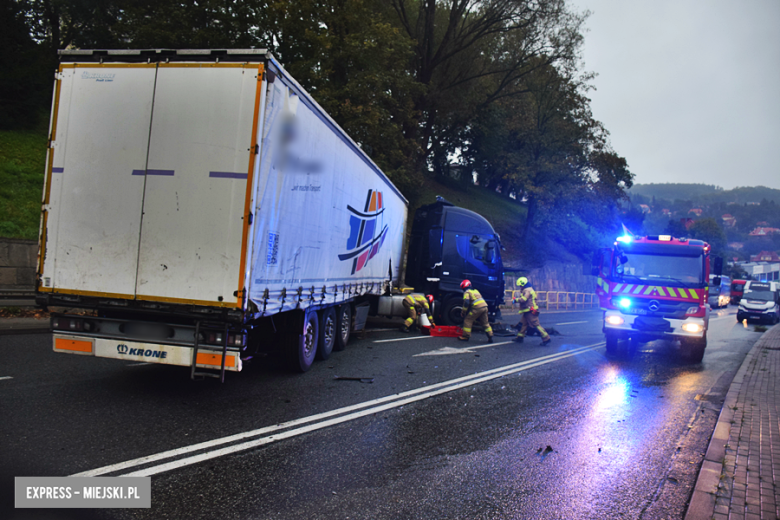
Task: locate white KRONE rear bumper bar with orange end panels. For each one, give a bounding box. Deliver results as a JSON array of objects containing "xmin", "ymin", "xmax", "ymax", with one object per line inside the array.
[{"xmin": 54, "ymin": 336, "xmax": 242, "ymax": 372}]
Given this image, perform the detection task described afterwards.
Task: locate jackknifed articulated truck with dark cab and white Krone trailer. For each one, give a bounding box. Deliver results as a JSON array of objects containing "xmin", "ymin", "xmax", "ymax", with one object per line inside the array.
[{"xmin": 36, "ymin": 50, "xmax": 504, "ymax": 380}]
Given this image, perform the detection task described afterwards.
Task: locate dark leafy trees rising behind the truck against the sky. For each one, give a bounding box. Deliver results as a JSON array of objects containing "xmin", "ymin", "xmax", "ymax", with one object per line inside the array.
[{"xmin": 0, "ymin": 0, "xmax": 641, "ymax": 260}]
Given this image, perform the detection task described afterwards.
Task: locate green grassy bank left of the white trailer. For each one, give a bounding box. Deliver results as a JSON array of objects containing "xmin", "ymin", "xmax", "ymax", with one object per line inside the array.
[{"xmin": 0, "ymin": 131, "xmax": 46, "ymax": 240}]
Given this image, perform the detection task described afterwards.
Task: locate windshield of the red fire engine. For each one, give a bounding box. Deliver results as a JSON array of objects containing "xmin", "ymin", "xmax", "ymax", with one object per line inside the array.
[{"xmin": 615, "ymin": 252, "xmax": 704, "ymax": 284}]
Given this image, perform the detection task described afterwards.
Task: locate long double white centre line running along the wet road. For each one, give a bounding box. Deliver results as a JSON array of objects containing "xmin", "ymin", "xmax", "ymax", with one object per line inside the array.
[{"xmin": 71, "ymin": 341, "xmax": 604, "ymax": 477}]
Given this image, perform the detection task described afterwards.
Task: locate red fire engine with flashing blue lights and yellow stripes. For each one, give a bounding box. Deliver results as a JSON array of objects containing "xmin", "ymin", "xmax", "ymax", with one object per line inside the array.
[{"xmin": 591, "ymin": 234, "xmax": 723, "ymax": 362}]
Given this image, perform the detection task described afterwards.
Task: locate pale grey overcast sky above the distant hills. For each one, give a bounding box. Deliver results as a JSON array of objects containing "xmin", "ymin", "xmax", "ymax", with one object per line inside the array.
[{"xmin": 570, "ymin": 0, "xmax": 780, "ymax": 189}]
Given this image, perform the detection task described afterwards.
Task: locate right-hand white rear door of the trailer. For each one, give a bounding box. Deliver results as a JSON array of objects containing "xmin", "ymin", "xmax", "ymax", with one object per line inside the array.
[{"xmin": 136, "ymin": 63, "xmax": 259, "ymax": 306}]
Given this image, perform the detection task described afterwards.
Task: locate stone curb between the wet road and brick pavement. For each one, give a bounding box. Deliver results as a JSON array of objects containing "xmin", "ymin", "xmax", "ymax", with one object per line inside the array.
[{"xmin": 685, "ymin": 325, "xmax": 777, "ymax": 520}]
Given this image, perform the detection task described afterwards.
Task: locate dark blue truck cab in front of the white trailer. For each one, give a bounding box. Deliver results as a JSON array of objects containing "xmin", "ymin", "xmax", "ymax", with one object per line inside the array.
[{"xmin": 405, "ymin": 197, "xmax": 504, "ymax": 325}]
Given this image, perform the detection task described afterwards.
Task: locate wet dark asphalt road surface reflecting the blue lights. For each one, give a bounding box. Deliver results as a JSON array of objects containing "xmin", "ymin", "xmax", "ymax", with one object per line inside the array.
[{"xmin": 0, "ymin": 308, "xmax": 760, "ymax": 519}]
